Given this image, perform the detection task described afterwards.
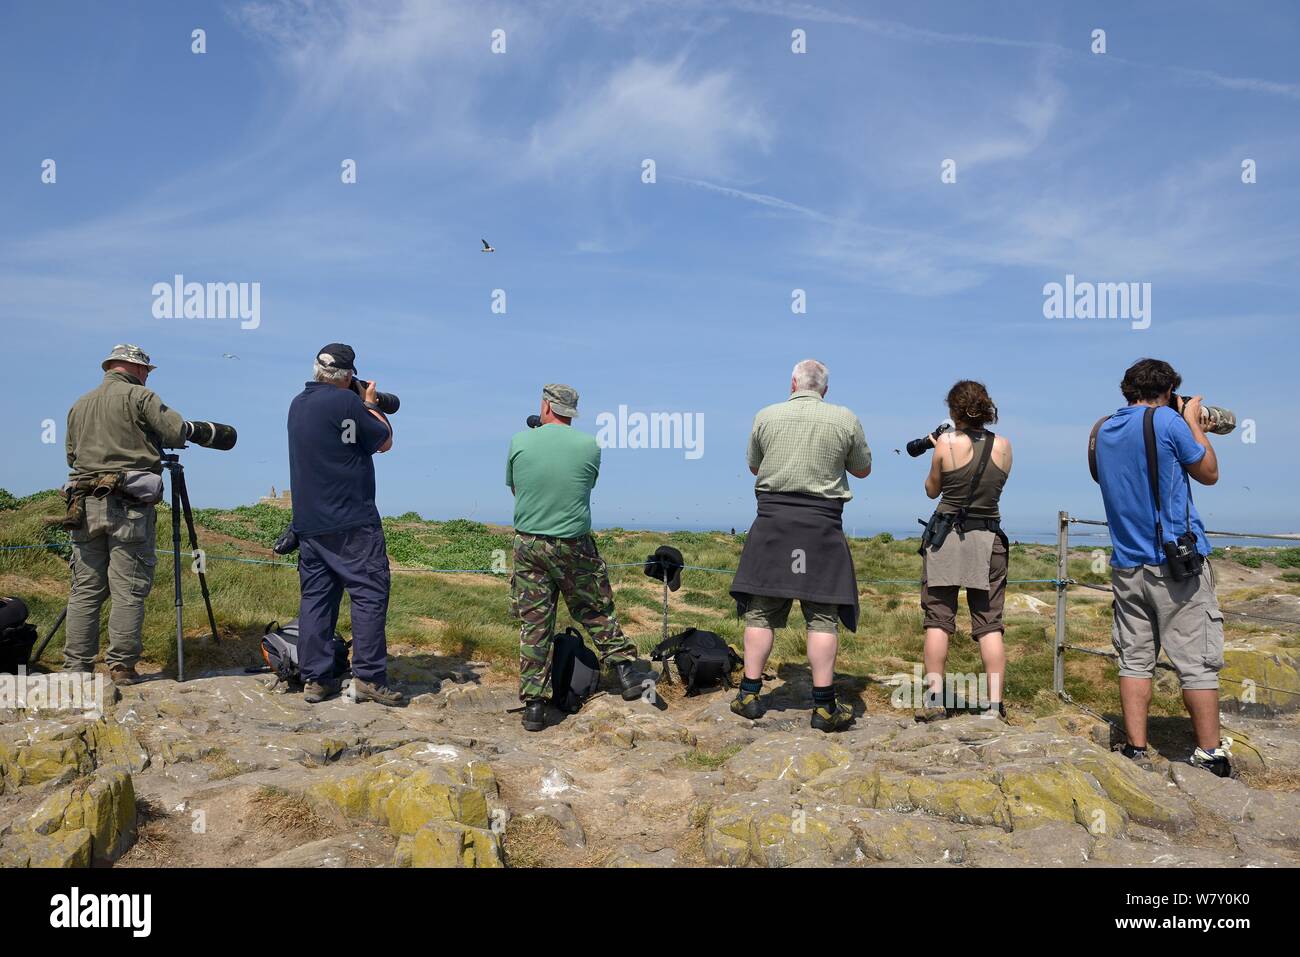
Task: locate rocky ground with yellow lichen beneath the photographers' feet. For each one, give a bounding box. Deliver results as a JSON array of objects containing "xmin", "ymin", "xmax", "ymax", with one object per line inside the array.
[{"xmin": 0, "ymin": 655, "xmax": 1300, "ymax": 867}]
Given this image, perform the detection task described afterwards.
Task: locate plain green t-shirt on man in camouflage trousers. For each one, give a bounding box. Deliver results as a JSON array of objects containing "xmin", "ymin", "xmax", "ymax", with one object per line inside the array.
[{"xmin": 506, "ymin": 423, "xmax": 601, "ymax": 538}]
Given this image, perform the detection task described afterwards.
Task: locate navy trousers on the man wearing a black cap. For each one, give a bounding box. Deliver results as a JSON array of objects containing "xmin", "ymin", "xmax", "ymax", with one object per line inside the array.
[{"xmin": 298, "ymin": 525, "xmax": 389, "ymax": 685}]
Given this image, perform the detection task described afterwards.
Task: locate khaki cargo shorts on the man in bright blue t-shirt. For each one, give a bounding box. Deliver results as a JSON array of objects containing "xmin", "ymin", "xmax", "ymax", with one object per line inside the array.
[{"xmin": 1110, "ymin": 559, "xmax": 1223, "ymax": 690}]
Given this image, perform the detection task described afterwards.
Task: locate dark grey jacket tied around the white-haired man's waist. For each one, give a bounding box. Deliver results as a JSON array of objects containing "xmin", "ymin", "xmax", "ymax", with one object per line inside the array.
[{"xmin": 731, "ymin": 492, "xmax": 858, "ymax": 632}]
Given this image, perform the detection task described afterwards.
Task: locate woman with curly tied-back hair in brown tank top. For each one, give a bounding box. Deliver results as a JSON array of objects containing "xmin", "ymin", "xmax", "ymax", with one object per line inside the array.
[{"xmin": 915, "ymin": 380, "xmax": 1011, "ymax": 720}]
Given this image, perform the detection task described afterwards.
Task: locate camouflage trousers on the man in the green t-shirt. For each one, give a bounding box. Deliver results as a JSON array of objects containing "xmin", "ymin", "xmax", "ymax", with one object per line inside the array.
[{"xmin": 510, "ymin": 534, "xmax": 637, "ymax": 701}]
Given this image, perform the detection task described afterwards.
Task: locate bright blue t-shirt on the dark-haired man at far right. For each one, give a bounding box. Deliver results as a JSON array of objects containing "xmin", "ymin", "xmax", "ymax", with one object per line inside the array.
[{"xmin": 1097, "ymin": 406, "xmax": 1210, "ymax": 568}]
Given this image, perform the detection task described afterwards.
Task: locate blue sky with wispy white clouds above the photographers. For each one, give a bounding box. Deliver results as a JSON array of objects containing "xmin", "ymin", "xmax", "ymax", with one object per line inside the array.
[{"xmin": 0, "ymin": 0, "xmax": 1300, "ymax": 534}]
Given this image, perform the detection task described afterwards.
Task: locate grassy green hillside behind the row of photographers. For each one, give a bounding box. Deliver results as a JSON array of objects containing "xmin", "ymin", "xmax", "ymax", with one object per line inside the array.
[{"xmin": 0, "ymin": 490, "xmax": 1300, "ymax": 714}]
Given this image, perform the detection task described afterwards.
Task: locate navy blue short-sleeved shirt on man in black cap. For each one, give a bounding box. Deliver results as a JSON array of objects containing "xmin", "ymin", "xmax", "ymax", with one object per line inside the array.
[{"xmin": 289, "ymin": 382, "xmax": 389, "ymax": 538}]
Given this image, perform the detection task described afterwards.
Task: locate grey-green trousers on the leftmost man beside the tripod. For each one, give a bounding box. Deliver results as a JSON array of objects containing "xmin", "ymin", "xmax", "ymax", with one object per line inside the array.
[{"xmin": 64, "ymin": 495, "xmax": 157, "ymax": 671}]
